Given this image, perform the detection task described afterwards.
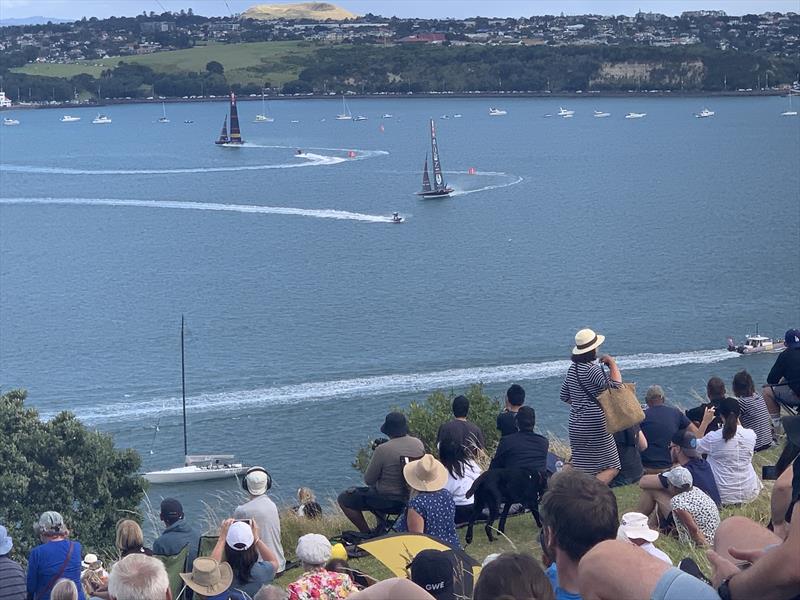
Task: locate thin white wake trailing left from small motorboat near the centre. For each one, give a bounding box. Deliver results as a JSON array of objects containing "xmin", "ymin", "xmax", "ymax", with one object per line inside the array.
[{"xmin": 0, "ymin": 198, "xmax": 392, "ymax": 223}]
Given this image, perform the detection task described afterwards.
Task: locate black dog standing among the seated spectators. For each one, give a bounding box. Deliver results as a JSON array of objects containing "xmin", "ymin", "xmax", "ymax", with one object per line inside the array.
[{"xmin": 466, "ymin": 468, "xmax": 547, "ymax": 544}]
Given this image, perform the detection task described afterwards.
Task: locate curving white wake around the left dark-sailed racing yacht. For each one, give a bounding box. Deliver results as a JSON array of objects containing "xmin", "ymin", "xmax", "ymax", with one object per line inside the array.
[{"xmin": 0, "ymin": 143, "xmax": 389, "ymax": 175}]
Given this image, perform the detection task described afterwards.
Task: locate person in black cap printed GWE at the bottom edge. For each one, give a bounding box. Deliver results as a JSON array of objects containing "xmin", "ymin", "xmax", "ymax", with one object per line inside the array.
[{"xmin": 408, "ymin": 550, "xmax": 472, "ymax": 600}]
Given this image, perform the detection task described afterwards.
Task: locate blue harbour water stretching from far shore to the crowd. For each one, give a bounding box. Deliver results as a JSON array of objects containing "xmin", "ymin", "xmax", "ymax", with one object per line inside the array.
[{"xmin": 0, "ymin": 98, "xmax": 800, "ymax": 520}]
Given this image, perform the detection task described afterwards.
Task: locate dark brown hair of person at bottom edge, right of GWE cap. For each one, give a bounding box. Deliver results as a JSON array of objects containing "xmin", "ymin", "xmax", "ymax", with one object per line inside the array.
[{"xmin": 472, "ymin": 553, "xmax": 555, "ymax": 600}]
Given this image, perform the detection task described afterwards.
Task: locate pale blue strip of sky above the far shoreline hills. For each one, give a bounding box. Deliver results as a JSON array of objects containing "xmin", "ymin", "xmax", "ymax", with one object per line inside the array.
[{"xmin": 0, "ymin": 0, "xmax": 800, "ymax": 19}]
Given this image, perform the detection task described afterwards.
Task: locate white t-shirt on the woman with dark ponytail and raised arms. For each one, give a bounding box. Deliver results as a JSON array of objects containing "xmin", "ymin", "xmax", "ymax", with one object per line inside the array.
[{"xmin": 697, "ymin": 425, "xmax": 764, "ymax": 504}]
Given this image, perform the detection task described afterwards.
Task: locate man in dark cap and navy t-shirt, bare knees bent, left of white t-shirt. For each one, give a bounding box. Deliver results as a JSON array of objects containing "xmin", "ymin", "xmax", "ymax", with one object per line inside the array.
[{"xmin": 637, "ymin": 430, "xmax": 722, "ymax": 525}]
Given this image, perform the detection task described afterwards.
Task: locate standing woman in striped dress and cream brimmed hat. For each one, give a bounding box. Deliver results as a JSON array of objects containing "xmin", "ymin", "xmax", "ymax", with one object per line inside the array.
[{"xmin": 561, "ymin": 329, "xmax": 622, "ymax": 483}]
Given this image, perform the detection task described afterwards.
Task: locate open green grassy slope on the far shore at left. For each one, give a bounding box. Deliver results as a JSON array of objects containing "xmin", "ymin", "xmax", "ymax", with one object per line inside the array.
[{"xmin": 12, "ymin": 42, "xmax": 318, "ymax": 86}]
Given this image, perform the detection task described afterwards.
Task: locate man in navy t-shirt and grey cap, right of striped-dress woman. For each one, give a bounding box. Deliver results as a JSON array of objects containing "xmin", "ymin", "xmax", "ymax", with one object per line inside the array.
[{"xmin": 640, "ymin": 385, "xmax": 697, "ymax": 474}]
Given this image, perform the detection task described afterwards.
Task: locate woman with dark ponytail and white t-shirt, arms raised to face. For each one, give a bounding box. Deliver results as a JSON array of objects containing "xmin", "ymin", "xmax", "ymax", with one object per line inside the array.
[{"xmin": 697, "ymin": 398, "xmax": 763, "ymax": 505}]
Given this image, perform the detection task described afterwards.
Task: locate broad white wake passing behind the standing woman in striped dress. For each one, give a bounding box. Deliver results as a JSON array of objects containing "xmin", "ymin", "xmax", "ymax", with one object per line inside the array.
[{"xmin": 61, "ymin": 350, "xmax": 740, "ymax": 423}]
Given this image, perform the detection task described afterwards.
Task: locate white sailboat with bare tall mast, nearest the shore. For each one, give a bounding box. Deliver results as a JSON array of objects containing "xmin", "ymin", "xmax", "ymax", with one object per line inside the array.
[{"xmin": 143, "ymin": 316, "xmax": 248, "ymax": 483}]
